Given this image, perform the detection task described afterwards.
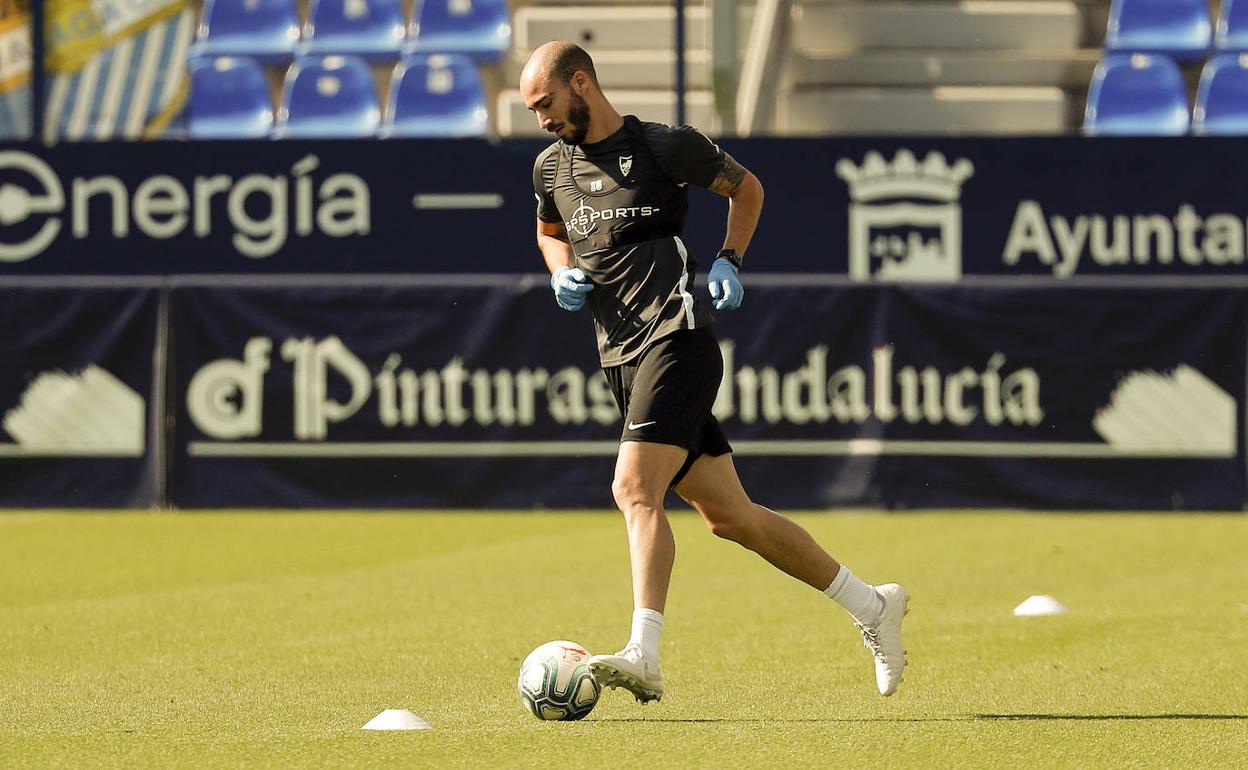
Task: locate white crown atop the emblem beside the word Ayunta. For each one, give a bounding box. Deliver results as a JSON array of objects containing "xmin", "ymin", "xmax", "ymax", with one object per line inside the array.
[{"xmin": 836, "ymin": 150, "xmax": 975, "ymax": 203}]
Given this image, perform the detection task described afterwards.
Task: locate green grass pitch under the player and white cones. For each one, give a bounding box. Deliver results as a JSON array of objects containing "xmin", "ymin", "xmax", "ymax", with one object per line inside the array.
[{"xmin": 0, "ymin": 512, "xmax": 1248, "ymax": 769}]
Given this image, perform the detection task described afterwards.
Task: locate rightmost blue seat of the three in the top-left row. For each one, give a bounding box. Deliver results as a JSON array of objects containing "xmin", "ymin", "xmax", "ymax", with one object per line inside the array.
[{"xmin": 407, "ymin": 0, "xmax": 512, "ymax": 62}]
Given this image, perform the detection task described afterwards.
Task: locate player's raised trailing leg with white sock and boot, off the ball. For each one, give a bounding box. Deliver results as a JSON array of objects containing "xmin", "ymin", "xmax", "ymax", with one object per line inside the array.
[{"xmin": 676, "ymin": 453, "xmax": 910, "ymax": 695}]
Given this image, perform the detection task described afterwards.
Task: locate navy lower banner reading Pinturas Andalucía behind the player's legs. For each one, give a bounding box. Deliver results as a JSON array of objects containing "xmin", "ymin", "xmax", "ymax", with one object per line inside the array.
[{"xmin": 171, "ymin": 277, "xmax": 1246, "ymax": 509}]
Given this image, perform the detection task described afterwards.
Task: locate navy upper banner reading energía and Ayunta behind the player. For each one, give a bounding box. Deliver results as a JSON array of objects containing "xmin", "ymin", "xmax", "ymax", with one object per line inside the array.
[{"xmin": 7, "ymin": 137, "xmax": 1248, "ymax": 279}]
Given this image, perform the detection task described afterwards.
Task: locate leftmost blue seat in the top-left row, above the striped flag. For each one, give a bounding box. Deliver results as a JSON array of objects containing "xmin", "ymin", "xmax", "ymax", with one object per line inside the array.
[{"xmin": 191, "ymin": 0, "xmax": 300, "ymax": 61}]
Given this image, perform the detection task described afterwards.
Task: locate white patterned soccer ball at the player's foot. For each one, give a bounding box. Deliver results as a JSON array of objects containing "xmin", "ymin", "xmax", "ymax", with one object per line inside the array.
[{"xmin": 515, "ymin": 641, "xmax": 602, "ymax": 721}]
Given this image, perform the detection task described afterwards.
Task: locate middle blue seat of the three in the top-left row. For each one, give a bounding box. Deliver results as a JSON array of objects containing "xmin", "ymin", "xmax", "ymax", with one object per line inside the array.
[{"xmin": 302, "ymin": 0, "xmax": 407, "ymax": 61}]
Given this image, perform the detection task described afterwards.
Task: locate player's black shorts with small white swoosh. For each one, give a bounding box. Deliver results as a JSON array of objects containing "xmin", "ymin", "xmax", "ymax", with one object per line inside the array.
[{"xmin": 603, "ymin": 328, "xmax": 733, "ymax": 485}]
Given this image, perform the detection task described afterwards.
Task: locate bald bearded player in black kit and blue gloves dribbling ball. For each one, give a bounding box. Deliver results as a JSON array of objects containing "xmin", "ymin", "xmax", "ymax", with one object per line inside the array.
[{"xmin": 520, "ymin": 41, "xmax": 909, "ymax": 703}]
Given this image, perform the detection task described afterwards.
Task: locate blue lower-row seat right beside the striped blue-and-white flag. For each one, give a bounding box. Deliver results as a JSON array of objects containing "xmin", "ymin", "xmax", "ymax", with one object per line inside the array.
[{"xmin": 187, "ymin": 56, "xmax": 273, "ymax": 139}]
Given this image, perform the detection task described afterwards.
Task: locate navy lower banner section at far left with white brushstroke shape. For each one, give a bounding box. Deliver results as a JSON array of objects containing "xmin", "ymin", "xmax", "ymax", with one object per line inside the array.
[{"xmin": 0, "ymin": 282, "xmax": 163, "ymax": 508}]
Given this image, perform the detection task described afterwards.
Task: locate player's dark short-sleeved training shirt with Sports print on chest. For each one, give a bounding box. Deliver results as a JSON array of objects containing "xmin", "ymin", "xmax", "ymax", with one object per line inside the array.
[{"xmin": 533, "ymin": 115, "xmax": 724, "ymax": 367}]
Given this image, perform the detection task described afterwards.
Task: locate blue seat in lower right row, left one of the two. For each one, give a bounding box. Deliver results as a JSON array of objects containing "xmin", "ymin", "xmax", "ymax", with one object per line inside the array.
[{"xmin": 1083, "ymin": 54, "xmax": 1189, "ymax": 136}]
